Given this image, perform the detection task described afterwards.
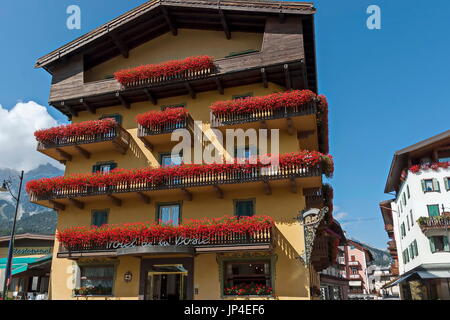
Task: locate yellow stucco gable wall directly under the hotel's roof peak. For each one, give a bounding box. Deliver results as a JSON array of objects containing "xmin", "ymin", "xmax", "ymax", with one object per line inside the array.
[{"xmin": 85, "ymin": 29, "xmax": 263, "ymax": 82}]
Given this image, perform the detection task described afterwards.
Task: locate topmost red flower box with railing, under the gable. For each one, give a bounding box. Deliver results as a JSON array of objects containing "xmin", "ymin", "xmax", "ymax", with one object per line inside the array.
[{"xmin": 114, "ymin": 56, "xmax": 214, "ymax": 86}]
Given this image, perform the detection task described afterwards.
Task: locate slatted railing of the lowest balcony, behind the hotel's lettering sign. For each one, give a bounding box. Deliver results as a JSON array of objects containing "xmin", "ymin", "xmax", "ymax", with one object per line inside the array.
[{"xmin": 58, "ymin": 228, "xmax": 273, "ymax": 257}]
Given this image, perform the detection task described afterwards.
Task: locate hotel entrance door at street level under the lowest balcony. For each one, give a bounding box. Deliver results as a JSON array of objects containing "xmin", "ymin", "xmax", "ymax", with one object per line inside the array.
[{"xmin": 145, "ymin": 265, "xmax": 188, "ymax": 300}]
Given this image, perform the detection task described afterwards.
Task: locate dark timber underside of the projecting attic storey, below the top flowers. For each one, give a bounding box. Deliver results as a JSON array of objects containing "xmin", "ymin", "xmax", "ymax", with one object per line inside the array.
[{"xmin": 50, "ymin": 60, "xmax": 305, "ymax": 118}]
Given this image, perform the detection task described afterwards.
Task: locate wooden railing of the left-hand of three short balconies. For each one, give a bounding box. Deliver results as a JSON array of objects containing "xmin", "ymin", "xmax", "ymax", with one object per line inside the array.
[{"xmin": 37, "ymin": 125, "xmax": 131, "ymax": 153}]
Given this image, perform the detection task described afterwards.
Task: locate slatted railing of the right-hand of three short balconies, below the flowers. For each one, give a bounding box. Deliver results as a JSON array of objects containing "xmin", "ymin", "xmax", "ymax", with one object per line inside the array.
[{"xmin": 211, "ymin": 102, "xmax": 318, "ymax": 127}]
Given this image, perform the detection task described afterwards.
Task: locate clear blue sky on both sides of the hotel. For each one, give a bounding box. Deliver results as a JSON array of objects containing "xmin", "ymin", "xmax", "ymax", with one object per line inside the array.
[{"xmin": 0, "ymin": 0, "xmax": 450, "ymax": 248}]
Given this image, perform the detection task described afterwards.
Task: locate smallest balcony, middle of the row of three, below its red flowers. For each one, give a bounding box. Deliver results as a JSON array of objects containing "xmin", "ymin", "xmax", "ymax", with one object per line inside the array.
[{"xmin": 138, "ymin": 115, "xmax": 194, "ymax": 150}]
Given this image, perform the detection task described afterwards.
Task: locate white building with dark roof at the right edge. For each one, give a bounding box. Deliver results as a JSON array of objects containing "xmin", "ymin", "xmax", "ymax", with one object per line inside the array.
[{"xmin": 380, "ymin": 130, "xmax": 450, "ymax": 300}]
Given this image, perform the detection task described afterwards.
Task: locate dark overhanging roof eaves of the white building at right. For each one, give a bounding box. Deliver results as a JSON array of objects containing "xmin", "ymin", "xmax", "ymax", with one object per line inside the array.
[{"xmin": 384, "ymin": 130, "xmax": 450, "ymax": 193}]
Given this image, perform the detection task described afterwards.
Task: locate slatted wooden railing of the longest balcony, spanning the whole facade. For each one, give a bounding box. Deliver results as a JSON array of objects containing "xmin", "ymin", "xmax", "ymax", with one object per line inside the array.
[{"xmin": 30, "ymin": 165, "xmax": 322, "ymax": 202}]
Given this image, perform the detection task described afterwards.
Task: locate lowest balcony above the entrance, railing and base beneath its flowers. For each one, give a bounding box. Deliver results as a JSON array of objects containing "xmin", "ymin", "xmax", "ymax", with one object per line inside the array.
[{"xmin": 57, "ymin": 229, "xmax": 273, "ymax": 259}]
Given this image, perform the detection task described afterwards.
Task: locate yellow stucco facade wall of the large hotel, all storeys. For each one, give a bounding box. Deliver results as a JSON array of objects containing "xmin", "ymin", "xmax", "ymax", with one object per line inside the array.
[{"xmin": 46, "ymin": 30, "xmax": 322, "ymax": 299}]
